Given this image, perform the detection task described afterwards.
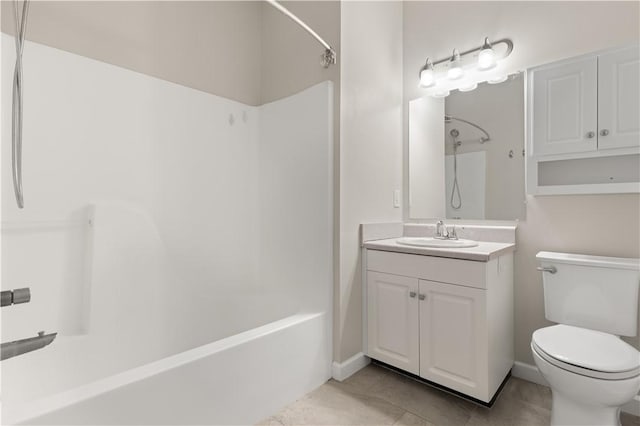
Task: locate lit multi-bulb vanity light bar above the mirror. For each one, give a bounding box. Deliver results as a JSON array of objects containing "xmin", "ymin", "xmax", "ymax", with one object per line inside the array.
[{"xmin": 419, "ymin": 37, "xmax": 513, "ymax": 97}]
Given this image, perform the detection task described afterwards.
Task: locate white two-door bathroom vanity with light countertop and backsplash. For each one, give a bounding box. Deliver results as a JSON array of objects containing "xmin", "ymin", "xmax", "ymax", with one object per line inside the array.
[{"xmin": 363, "ymin": 224, "xmax": 515, "ymax": 403}]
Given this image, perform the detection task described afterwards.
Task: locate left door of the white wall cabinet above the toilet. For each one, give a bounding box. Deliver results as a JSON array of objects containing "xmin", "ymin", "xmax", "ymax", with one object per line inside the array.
[{"xmin": 530, "ymin": 56, "xmax": 598, "ymax": 155}]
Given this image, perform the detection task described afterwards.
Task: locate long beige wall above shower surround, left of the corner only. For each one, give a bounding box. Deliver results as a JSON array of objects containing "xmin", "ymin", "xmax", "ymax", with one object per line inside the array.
[{"xmin": 2, "ymin": 1, "xmax": 262, "ymax": 105}]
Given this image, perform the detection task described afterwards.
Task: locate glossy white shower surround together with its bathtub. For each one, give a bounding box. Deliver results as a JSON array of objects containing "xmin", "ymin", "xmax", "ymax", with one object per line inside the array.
[{"xmin": 2, "ymin": 34, "xmax": 333, "ymax": 424}]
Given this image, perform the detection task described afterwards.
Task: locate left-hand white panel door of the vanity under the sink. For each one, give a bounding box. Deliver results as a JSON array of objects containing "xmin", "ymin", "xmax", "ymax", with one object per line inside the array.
[{"xmin": 367, "ymin": 271, "xmax": 419, "ymax": 374}]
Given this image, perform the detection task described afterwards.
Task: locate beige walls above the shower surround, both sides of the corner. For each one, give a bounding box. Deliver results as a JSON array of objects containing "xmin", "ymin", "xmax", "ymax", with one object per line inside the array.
[{"xmin": 1, "ymin": 1, "xmax": 340, "ymax": 105}]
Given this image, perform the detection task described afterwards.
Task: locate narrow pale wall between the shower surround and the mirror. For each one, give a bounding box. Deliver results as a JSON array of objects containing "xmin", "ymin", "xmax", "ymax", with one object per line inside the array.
[{"xmin": 334, "ymin": 2, "xmax": 403, "ymax": 362}]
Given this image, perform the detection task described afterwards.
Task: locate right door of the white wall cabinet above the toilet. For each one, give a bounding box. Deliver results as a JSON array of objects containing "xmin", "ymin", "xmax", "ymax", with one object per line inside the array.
[{"xmin": 598, "ymin": 46, "xmax": 640, "ymax": 149}]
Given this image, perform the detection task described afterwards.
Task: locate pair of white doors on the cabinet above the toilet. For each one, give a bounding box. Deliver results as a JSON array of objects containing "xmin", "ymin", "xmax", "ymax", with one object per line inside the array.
[{"xmin": 530, "ymin": 46, "xmax": 640, "ymax": 155}]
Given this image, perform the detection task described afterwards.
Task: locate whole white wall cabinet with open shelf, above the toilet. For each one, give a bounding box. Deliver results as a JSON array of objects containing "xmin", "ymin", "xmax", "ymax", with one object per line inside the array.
[{"xmin": 527, "ymin": 45, "xmax": 640, "ymax": 195}]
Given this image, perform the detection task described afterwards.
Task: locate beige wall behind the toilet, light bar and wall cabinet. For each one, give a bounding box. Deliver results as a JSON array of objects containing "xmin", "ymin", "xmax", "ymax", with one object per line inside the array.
[{"xmin": 403, "ymin": 2, "xmax": 640, "ymax": 363}]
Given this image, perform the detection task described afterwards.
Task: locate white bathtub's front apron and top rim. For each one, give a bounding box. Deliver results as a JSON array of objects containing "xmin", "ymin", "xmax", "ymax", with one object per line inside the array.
[{"xmin": 3, "ymin": 313, "xmax": 331, "ymax": 425}]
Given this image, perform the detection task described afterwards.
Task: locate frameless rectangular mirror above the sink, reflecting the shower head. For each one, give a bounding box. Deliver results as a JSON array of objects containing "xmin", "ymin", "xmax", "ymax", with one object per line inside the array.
[{"xmin": 409, "ymin": 73, "xmax": 525, "ymax": 220}]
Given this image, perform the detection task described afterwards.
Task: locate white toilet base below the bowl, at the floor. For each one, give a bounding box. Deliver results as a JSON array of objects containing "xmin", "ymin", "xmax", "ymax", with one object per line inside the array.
[{"xmin": 551, "ymin": 389, "xmax": 620, "ymax": 426}]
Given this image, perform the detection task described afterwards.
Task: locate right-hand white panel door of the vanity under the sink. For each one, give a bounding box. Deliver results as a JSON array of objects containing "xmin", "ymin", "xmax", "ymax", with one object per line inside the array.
[{"xmin": 420, "ymin": 280, "xmax": 488, "ymax": 399}]
